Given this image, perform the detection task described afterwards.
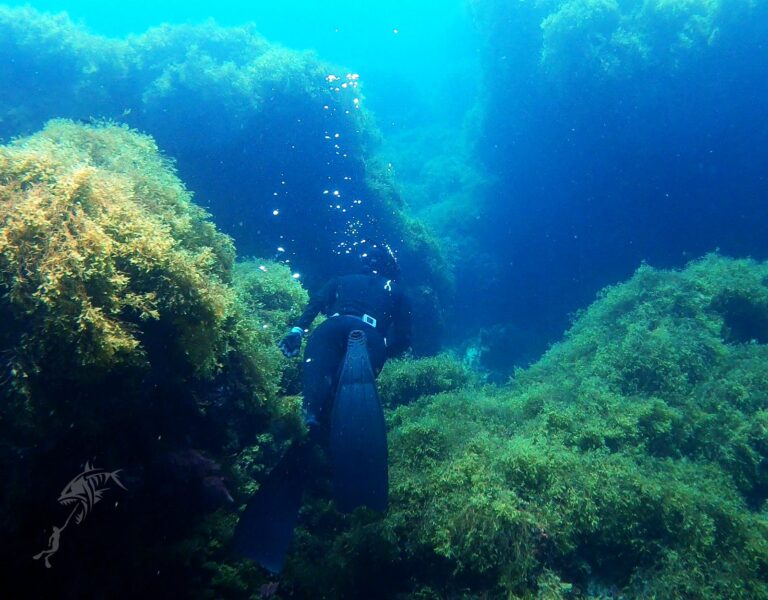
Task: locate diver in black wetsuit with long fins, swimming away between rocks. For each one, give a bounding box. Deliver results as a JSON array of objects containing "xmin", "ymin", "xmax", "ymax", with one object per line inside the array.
[{"xmin": 235, "ymin": 244, "xmax": 411, "ymax": 573}]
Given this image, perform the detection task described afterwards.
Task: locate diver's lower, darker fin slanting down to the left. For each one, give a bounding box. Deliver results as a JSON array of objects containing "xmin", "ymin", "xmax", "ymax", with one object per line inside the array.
[{"xmin": 233, "ymin": 444, "xmax": 310, "ymax": 573}]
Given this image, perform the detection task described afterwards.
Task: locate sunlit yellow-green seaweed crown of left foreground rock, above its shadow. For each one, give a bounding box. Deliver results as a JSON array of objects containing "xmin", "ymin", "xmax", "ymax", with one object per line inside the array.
[{"xmin": 0, "ymin": 121, "xmax": 234, "ymax": 387}]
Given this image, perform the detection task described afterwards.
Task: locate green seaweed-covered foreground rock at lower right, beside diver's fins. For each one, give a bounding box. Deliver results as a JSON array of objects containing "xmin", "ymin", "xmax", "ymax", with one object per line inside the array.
[{"xmin": 284, "ymin": 255, "xmax": 768, "ymax": 599}]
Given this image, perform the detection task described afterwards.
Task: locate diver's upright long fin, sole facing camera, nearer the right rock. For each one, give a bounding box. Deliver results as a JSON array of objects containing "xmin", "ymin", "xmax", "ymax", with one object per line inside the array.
[{"xmin": 331, "ymin": 330, "xmax": 389, "ymax": 512}]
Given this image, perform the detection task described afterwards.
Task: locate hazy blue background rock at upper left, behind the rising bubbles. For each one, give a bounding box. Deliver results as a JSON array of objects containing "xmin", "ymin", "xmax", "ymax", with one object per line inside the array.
[{"xmin": 0, "ymin": 8, "xmax": 452, "ymax": 338}]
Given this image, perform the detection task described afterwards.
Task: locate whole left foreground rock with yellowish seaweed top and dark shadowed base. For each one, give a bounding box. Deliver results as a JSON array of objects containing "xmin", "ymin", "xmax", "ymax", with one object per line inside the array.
[{"xmin": 0, "ymin": 120, "xmax": 306, "ymax": 597}]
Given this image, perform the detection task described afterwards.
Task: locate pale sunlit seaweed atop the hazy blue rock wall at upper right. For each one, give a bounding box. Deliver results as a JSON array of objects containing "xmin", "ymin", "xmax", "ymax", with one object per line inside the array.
[{"xmin": 469, "ymin": 0, "xmax": 766, "ymax": 104}]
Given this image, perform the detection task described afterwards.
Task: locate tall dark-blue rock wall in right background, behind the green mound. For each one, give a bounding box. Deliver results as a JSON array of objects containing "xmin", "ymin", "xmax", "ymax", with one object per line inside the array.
[{"xmin": 448, "ymin": 0, "xmax": 768, "ymax": 350}]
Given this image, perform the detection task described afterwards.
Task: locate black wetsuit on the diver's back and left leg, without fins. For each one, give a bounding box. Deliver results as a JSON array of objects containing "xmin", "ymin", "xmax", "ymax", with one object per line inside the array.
[{"xmin": 297, "ymin": 274, "xmax": 411, "ymax": 424}]
